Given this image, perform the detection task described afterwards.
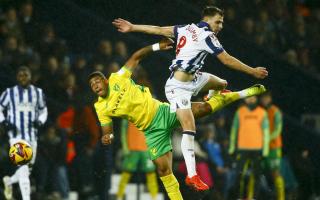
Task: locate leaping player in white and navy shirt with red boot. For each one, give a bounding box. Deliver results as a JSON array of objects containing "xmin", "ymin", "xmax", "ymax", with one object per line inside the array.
[{"xmin": 113, "ymin": 6, "xmax": 268, "ymax": 191}]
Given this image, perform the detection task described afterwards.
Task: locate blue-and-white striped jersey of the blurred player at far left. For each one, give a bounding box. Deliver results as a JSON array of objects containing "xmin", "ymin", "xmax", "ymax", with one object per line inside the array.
[{"xmin": 0, "ymin": 85, "xmax": 48, "ymax": 142}]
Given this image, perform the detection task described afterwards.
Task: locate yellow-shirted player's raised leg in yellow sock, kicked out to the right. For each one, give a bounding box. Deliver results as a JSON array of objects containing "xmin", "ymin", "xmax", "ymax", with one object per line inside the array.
[{"xmin": 191, "ymin": 84, "xmax": 266, "ymax": 119}]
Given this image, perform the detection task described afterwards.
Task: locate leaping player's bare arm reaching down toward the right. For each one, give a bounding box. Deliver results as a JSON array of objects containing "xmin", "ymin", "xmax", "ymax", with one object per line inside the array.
[{"xmin": 217, "ymin": 51, "xmax": 268, "ymax": 79}]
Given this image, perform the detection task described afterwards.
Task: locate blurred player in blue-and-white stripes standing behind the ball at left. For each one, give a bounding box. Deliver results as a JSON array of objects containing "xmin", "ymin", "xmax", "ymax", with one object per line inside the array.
[{"xmin": 0, "ymin": 66, "xmax": 48, "ymax": 200}]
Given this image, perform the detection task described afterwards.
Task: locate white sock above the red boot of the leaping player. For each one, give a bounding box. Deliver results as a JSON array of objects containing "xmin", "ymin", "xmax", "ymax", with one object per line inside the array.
[{"xmin": 181, "ymin": 131, "xmax": 197, "ymax": 177}]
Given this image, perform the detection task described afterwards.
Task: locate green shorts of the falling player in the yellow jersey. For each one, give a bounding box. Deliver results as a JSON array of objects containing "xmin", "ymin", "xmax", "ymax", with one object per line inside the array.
[{"xmin": 144, "ymin": 104, "xmax": 180, "ymax": 160}]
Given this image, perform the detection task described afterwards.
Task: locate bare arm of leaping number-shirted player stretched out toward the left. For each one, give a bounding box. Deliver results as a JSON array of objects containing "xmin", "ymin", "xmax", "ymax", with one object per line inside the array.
[{"xmin": 112, "ymin": 18, "xmax": 174, "ymax": 38}]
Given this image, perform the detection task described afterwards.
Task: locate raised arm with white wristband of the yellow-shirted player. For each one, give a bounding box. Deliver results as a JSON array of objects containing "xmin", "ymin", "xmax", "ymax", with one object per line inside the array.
[{"xmin": 125, "ymin": 38, "xmax": 173, "ymax": 71}]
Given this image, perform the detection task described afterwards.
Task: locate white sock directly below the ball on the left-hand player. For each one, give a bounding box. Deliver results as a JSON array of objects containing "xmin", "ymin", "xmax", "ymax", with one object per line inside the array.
[{"xmin": 19, "ymin": 165, "xmax": 31, "ymax": 200}]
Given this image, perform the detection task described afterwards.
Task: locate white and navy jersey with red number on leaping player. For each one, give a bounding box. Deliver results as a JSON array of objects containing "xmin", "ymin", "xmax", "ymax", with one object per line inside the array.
[{"xmin": 170, "ymin": 22, "xmax": 224, "ymax": 74}]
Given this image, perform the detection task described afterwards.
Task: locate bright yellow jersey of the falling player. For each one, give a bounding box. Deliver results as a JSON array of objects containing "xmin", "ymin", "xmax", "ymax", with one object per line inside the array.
[{"xmin": 94, "ymin": 66, "xmax": 161, "ymax": 130}]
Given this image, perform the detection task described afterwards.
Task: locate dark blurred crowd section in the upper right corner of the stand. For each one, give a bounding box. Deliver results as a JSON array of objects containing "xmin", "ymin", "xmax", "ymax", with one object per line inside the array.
[{"xmin": 219, "ymin": 0, "xmax": 320, "ymax": 77}]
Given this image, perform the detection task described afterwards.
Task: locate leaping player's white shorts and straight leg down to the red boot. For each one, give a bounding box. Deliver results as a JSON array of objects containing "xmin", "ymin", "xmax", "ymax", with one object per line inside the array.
[{"xmin": 165, "ymin": 78, "xmax": 209, "ymax": 191}]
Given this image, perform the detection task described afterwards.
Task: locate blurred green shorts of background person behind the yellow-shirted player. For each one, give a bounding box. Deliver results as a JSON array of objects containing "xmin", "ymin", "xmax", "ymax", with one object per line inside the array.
[{"xmin": 122, "ymin": 151, "xmax": 155, "ymax": 173}]
